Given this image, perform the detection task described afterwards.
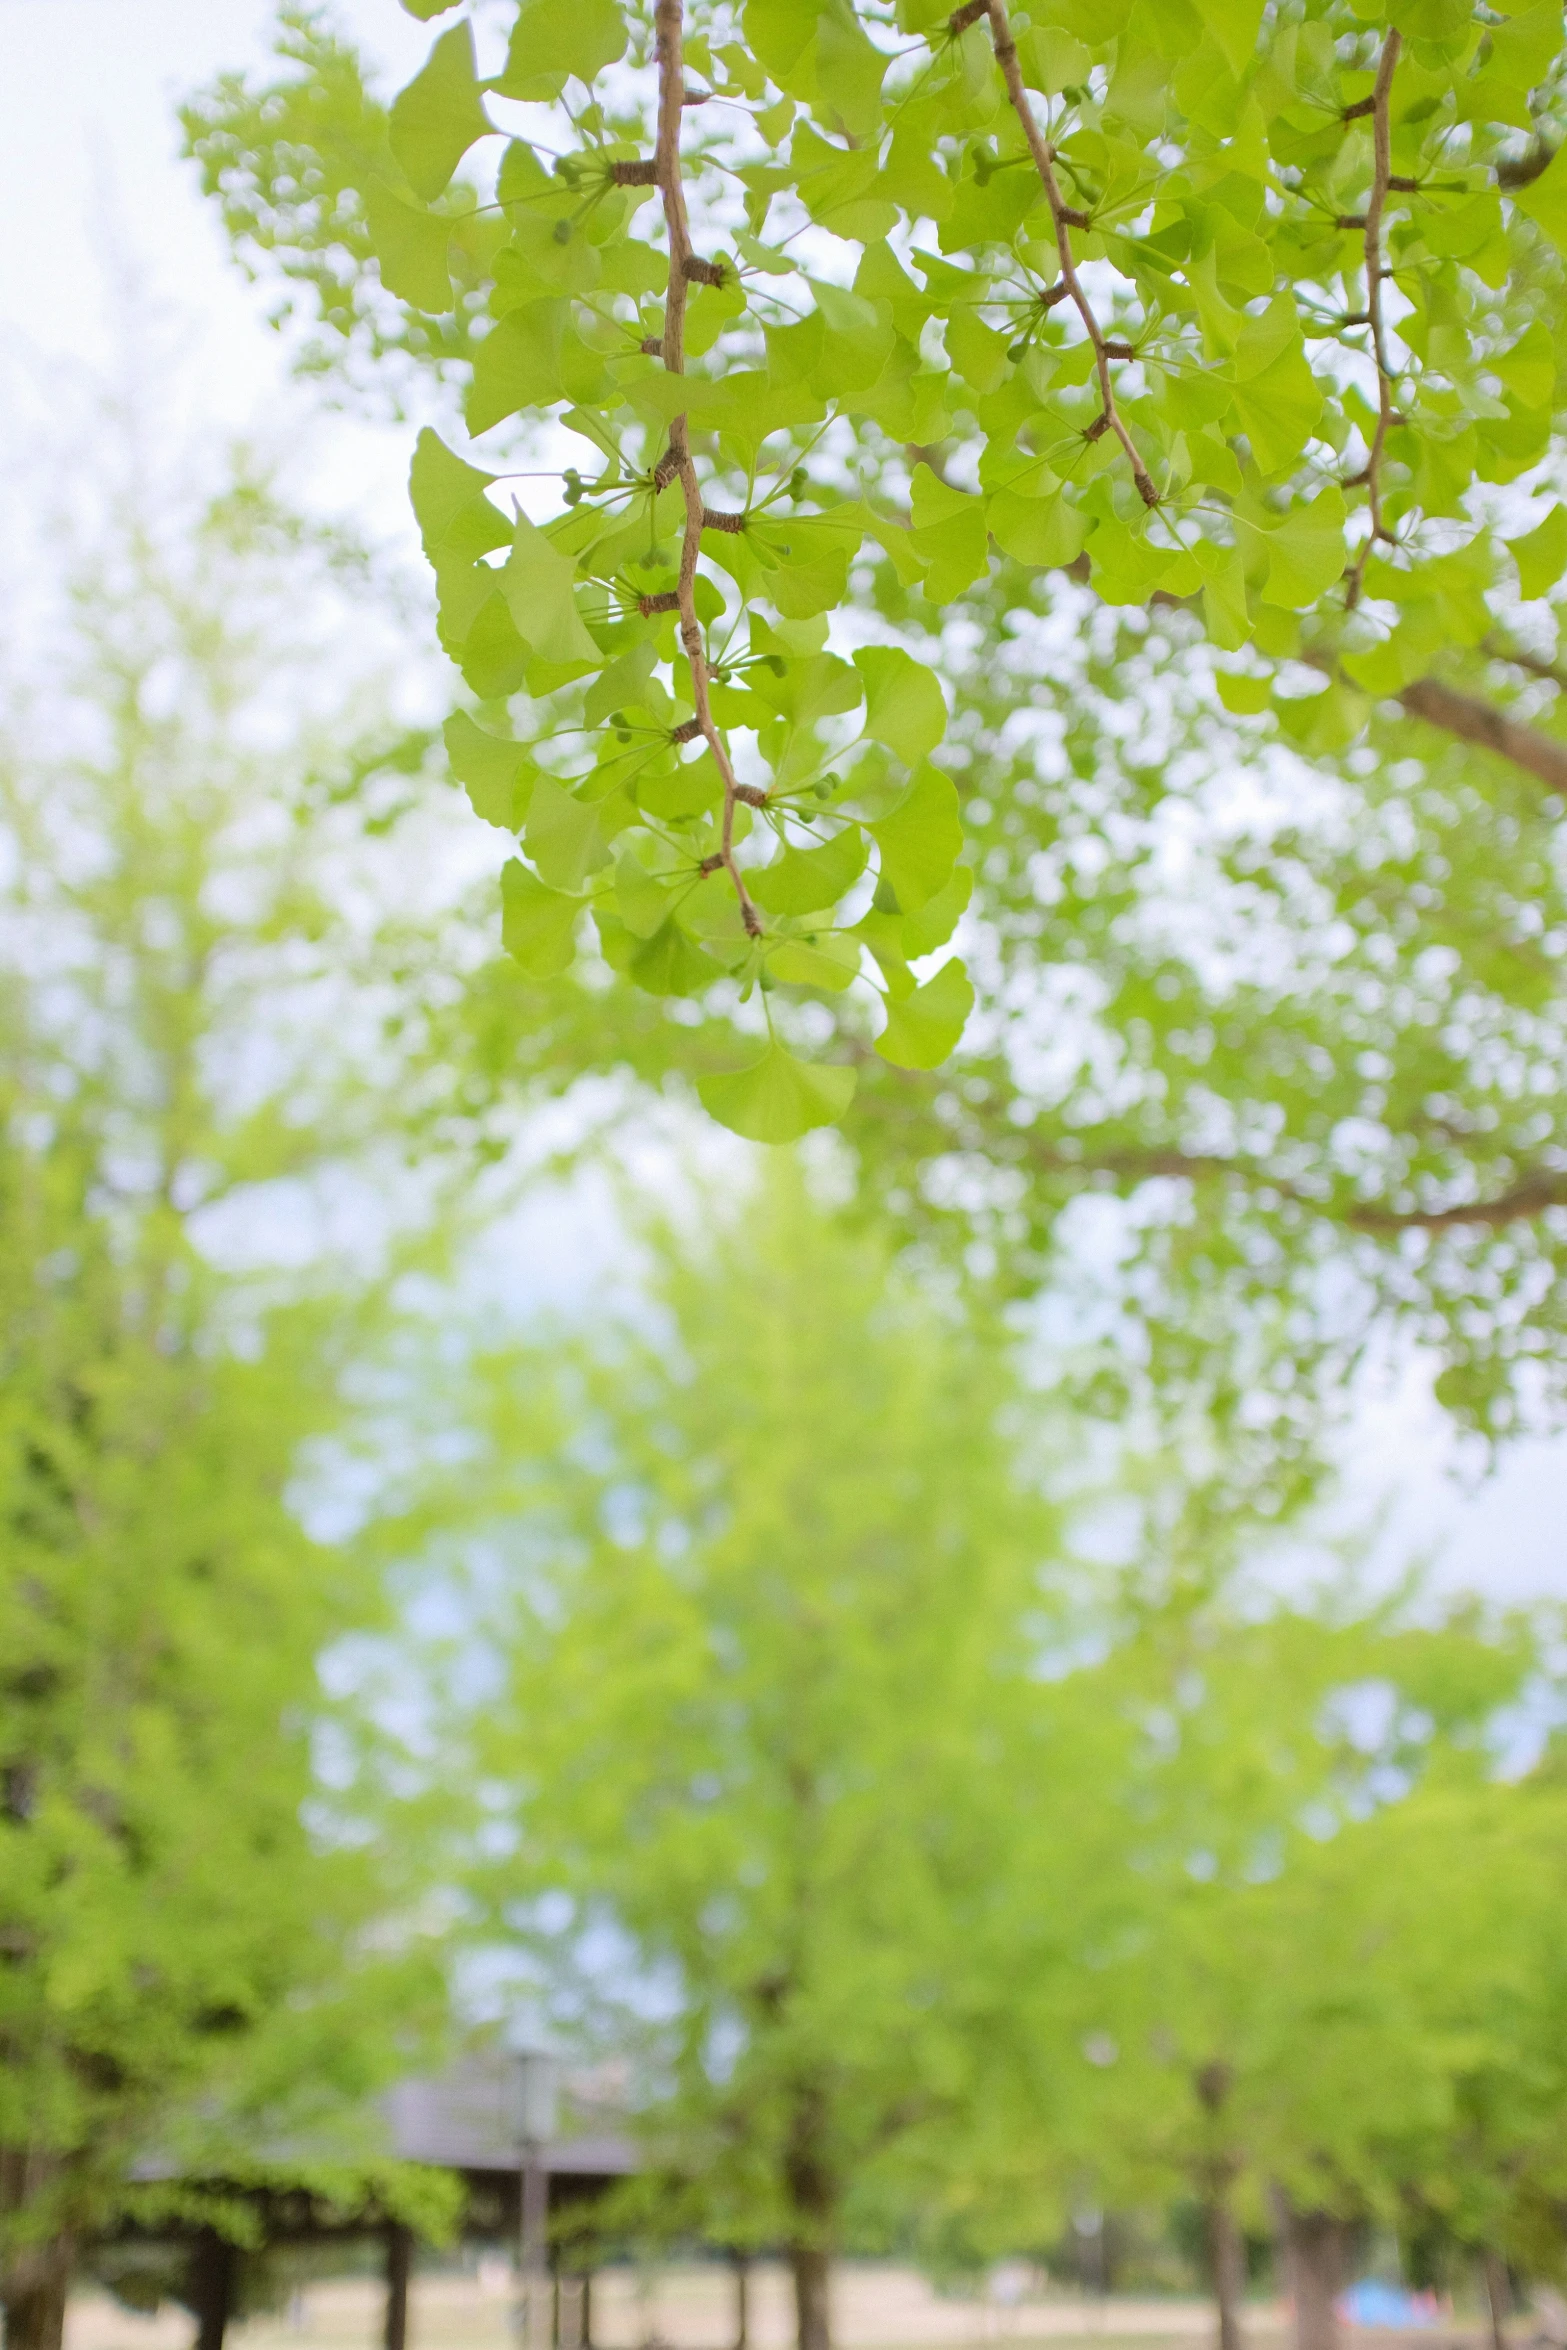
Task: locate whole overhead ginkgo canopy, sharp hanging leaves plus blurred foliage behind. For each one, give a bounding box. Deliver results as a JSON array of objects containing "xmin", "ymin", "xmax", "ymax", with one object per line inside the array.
[{"xmin": 186, "ymin": 0, "xmax": 1567, "ymax": 1436}]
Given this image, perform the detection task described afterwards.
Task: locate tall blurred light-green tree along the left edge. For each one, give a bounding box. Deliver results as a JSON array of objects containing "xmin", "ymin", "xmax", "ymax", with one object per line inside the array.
[{"xmin": 0, "ymin": 380, "xmax": 453, "ymax": 2350}]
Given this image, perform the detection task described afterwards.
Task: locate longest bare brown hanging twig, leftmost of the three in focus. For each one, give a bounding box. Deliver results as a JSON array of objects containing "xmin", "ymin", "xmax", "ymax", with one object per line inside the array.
[{"xmin": 653, "ymin": 0, "xmax": 766, "ymax": 938}]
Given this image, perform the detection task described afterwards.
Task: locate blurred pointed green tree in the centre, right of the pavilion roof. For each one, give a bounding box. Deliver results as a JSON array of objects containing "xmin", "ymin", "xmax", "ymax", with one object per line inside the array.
[{"xmin": 404, "ymin": 1161, "xmax": 1076, "ymax": 2350}]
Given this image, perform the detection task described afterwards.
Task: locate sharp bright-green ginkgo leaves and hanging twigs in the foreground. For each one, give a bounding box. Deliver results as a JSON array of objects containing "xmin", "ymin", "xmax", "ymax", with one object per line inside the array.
[{"xmin": 190, "ymin": 0, "xmax": 1567, "ymax": 1140}]
